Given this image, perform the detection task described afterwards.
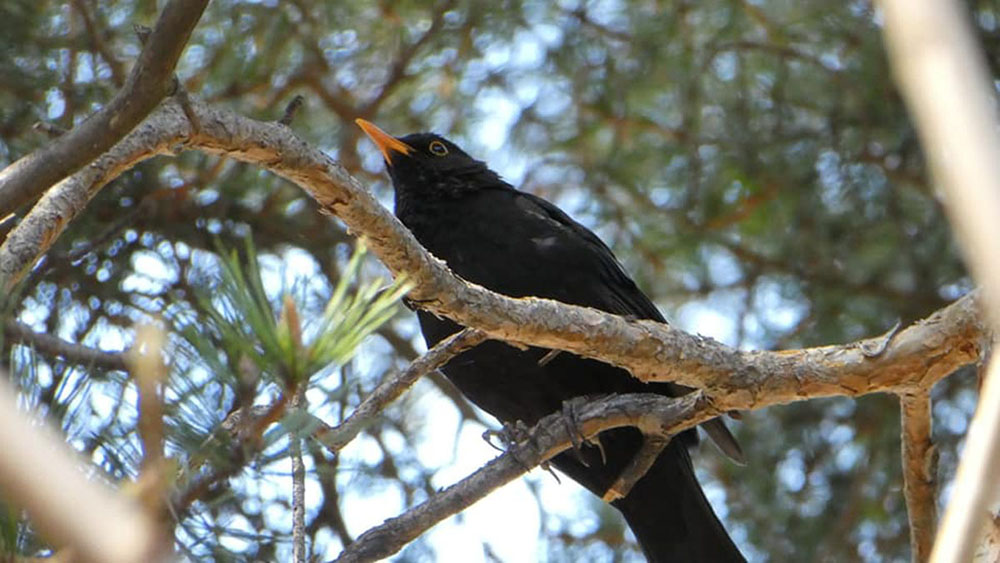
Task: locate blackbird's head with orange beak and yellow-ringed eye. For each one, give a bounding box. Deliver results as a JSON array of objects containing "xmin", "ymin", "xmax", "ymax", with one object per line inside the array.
[{"xmin": 356, "ymin": 119, "xmax": 510, "ymax": 209}]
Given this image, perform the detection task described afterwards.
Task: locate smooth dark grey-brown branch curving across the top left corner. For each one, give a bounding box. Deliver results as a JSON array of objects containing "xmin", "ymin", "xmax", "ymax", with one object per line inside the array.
[{"xmin": 0, "ymin": 0, "xmax": 208, "ymax": 217}]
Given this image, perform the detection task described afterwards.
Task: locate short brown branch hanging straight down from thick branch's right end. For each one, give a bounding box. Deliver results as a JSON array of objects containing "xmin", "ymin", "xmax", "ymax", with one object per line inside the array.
[{"xmin": 899, "ymin": 389, "xmax": 937, "ymax": 562}]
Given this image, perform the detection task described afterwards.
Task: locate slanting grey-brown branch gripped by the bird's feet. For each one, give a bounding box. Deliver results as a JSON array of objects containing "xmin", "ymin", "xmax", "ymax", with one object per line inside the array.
[{"xmin": 336, "ymin": 393, "xmax": 720, "ymax": 563}]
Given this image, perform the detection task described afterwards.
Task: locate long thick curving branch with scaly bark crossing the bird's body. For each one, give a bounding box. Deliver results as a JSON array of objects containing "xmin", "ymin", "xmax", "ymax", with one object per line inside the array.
[{"xmin": 0, "ymin": 101, "xmax": 985, "ymax": 410}]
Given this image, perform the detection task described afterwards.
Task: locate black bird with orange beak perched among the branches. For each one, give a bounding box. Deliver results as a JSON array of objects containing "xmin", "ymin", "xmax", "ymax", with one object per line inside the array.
[{"xmin": 357, "ymin": 119, "xmax": 744, "ymax": 563}]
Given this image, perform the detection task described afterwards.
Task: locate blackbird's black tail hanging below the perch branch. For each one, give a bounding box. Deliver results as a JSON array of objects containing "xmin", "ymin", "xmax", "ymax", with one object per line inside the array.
[{"xmin": 614, "ymin": 440, "xmax": 746, "ymax": 563}]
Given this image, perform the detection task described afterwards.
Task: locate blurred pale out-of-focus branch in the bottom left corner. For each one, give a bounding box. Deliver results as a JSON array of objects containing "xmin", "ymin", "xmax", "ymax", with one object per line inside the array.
[{"xmin": 0, "ymin": 375, "xmax": 167, "ymax": 563}]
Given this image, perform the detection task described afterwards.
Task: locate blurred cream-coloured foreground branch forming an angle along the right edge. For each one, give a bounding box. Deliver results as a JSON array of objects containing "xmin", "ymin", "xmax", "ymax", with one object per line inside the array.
[{"xmin": 881, "ymin": 0, "xmax": 1000, "ymax": 563}]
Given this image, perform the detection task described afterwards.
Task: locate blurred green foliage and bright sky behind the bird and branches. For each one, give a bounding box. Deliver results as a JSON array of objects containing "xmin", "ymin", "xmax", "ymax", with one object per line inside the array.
[{"xmin": 0, "ymin": 0, "xmax": 1000, "ymax": 561}]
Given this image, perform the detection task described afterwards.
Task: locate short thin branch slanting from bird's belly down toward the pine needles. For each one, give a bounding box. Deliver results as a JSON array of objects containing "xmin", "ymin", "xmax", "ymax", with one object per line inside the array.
[{"xmin": 316, "ymin": 329, "xmax": 486, "ymax": 453}]
